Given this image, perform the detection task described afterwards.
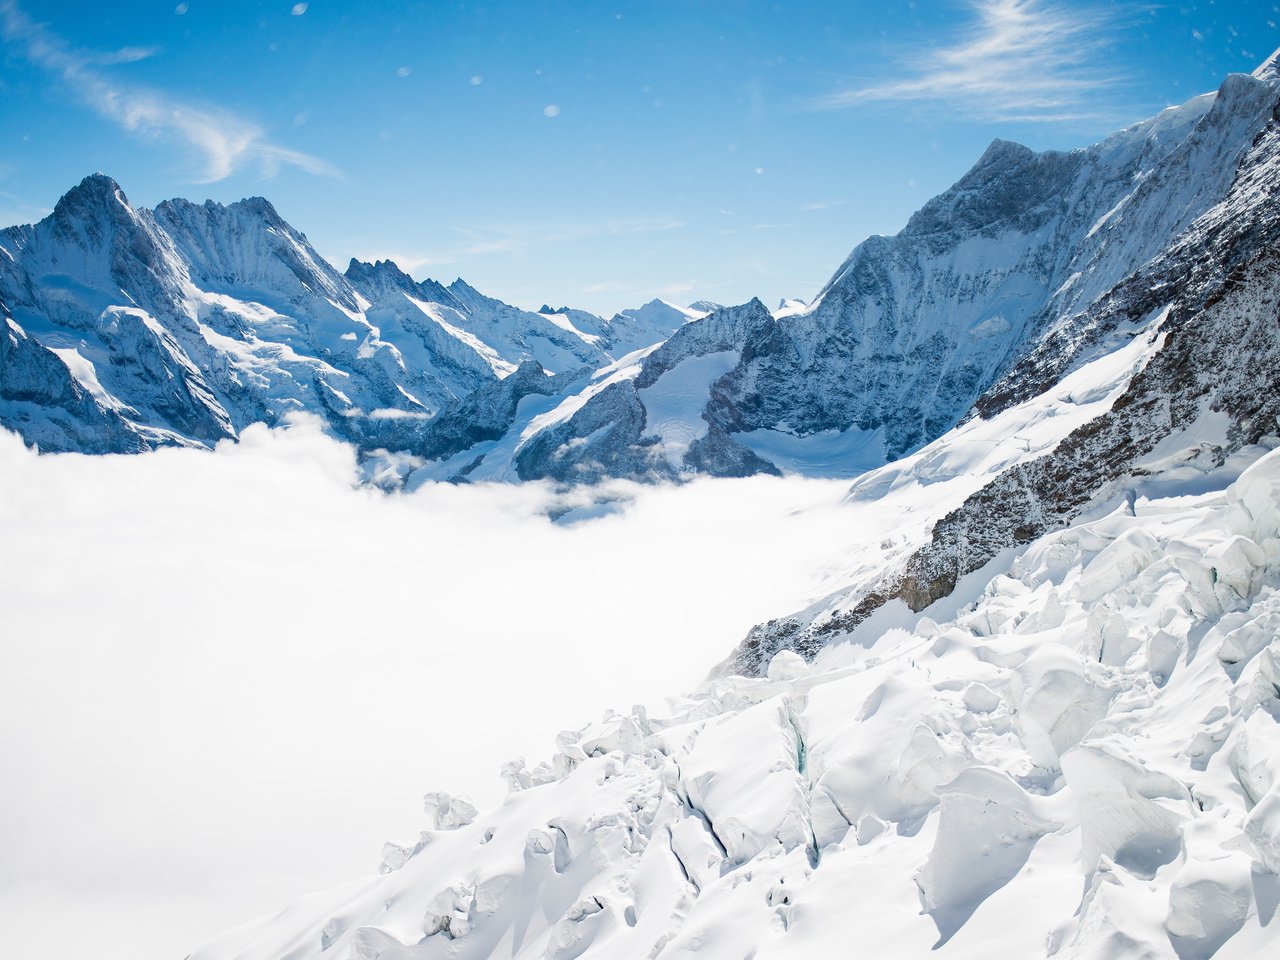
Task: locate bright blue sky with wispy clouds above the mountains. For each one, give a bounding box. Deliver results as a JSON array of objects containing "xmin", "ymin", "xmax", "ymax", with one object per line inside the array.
[{"xmin": 0, "ymin": 0, "xmax": 1280, "ymax": 314}]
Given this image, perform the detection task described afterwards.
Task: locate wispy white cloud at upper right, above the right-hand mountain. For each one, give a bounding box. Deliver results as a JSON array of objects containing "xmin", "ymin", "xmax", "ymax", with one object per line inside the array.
[{"xmin": 815, "ymin": 0, "xmax": 1123, "ymax": 123}]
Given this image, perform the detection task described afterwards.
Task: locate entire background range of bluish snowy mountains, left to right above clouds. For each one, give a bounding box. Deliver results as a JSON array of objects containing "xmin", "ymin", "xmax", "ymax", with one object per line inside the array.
[{"xmin": 0, "ymin": 61, "xmax": 1280, "ymax": 483}]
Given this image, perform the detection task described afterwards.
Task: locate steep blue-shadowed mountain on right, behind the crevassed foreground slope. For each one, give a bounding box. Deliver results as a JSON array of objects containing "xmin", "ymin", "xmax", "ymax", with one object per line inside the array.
[{"xmin": 373, "ymin": 61, "xmax": 1280, "ymax": 481}]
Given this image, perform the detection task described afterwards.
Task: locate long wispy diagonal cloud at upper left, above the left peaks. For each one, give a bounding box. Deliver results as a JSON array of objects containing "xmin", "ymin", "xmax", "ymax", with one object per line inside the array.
[{"xmin": 0, "ymin": 0, "xmax": 339, "ymax": 183}]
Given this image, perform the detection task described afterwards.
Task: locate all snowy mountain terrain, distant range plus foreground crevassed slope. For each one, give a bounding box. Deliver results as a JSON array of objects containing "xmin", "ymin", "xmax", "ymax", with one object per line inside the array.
[{"xmin": 0, "ymin": 39, "xmax": 1280, "ymax": 960}]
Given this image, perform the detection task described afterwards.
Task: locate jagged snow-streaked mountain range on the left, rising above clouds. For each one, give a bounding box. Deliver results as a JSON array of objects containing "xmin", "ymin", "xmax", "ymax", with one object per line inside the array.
[{"xmin": 0, "ymin": 185, "xmax": 689, "ymax": 453}]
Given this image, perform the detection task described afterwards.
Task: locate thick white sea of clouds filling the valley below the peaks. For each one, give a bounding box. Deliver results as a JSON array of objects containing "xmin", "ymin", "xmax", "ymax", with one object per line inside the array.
[{"xmin": 0, "ymin": 421, "xmax": 858, "ymax": 960}]
